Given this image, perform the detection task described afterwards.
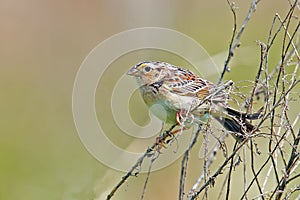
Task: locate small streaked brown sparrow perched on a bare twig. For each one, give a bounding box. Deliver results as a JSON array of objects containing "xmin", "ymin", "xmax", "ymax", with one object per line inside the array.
[{"xmin": 127, "ymin": 61, "xmax": 260, "ymax": 141}]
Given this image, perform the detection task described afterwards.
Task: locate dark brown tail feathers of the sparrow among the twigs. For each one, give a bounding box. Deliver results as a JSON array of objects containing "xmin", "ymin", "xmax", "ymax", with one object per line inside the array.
[{"xmin": 212, "ymin": 108, "xmax": 261, "ymax": 141}]
